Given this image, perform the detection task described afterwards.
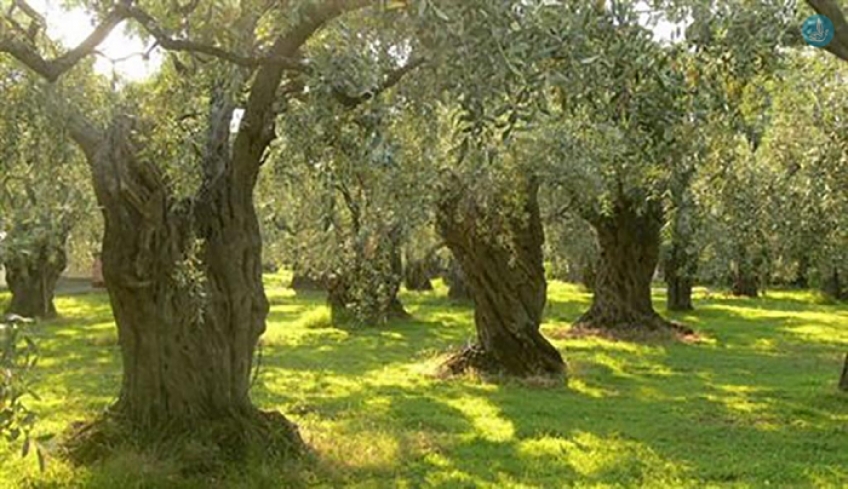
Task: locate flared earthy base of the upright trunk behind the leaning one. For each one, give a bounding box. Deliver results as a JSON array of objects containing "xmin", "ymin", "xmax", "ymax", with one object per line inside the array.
[{"xmin": 568, "ymin": 310, "xmax": 698, "ymax": 342}]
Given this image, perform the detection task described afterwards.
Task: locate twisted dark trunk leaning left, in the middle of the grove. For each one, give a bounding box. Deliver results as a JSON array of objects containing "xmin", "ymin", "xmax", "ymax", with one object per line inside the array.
[{"xmin": 437, "ymin": 175, "xmax": 565, "ymax": 377}]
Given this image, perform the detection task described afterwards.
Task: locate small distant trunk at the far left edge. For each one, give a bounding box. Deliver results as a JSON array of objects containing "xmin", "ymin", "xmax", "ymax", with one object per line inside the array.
[{"xmin": 4, "ymin": 236, "xmax": 68, "ymax": 318}]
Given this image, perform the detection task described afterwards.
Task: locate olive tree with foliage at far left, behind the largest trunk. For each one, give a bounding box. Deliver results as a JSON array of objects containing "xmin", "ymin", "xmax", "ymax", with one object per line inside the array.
[{"xmin": 0, "ymin": 61, "xmax": 93, "ymax": 318}]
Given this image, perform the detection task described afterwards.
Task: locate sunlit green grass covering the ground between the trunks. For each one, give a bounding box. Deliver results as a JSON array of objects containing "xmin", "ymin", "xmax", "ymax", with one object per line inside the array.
[{"xmin": 0, "ymin": 279, "xmax": 848, "ymax": 488}]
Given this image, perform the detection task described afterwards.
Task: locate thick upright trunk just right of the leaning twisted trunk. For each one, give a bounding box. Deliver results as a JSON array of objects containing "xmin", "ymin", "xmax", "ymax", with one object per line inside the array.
[{"xmin": 576, "ymin": 199, "xmax": 672, "ymax": 332}]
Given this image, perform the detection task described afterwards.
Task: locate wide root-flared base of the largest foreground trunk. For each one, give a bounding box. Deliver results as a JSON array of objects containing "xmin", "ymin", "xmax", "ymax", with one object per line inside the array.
[{"xmin": 62, "ymin": 409, "xmax": 308, "ymax": 475}]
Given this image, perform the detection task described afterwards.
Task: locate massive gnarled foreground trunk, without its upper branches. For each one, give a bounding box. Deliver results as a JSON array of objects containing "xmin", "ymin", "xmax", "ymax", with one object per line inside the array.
[{"xmin": 68, "ymin": 115, "xmax": 302, "ymax": 457}]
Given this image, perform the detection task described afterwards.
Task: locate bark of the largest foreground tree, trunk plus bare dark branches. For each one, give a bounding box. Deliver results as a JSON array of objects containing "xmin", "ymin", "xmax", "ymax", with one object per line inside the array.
[{"xmin": 0, "ymin": 0, "xmax": 422, "ymax": 462}]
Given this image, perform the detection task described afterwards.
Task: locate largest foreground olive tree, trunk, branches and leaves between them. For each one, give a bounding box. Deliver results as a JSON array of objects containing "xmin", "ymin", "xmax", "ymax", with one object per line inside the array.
[{"xmin": 0, "ymin": 0, "xmax": 434, "ymax": 451}]
